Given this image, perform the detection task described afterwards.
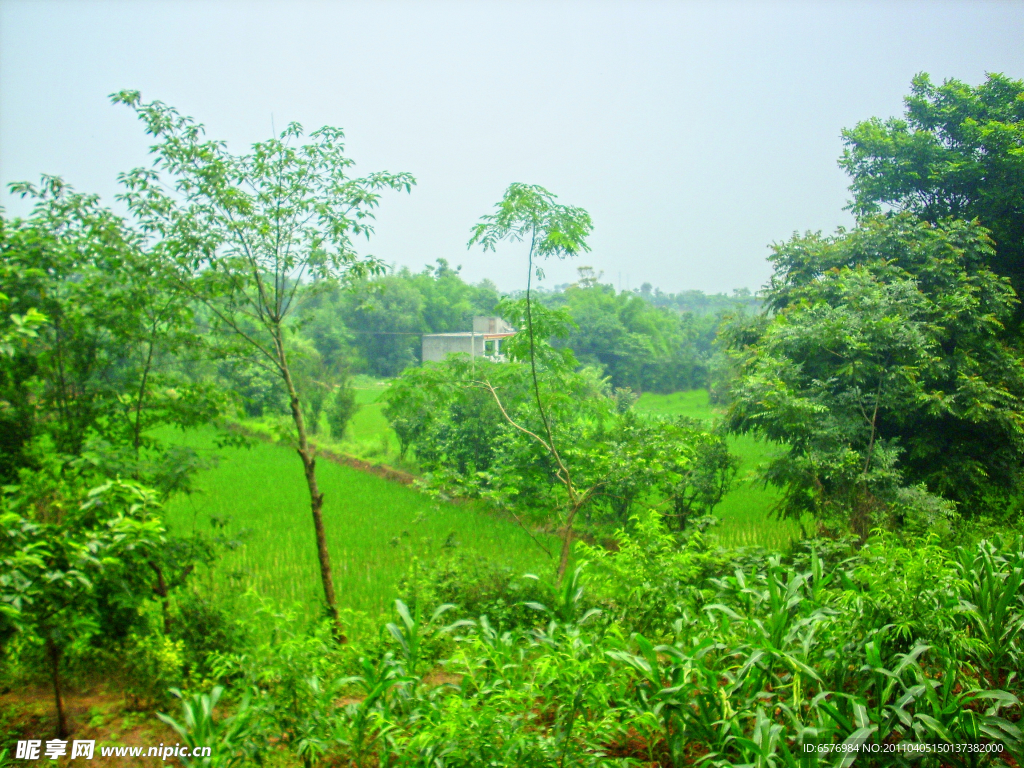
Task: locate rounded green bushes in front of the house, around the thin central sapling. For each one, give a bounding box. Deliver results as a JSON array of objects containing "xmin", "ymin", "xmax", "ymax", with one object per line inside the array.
[{"xmin": 384, "ymin": 348, "xmax": 735, "ymax": 528}]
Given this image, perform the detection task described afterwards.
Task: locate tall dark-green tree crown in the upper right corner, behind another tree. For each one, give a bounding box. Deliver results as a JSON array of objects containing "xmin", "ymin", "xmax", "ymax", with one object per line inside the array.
[{"xmin": 840, "ymin": 74, "xmax": 1024, "ymax": 313}]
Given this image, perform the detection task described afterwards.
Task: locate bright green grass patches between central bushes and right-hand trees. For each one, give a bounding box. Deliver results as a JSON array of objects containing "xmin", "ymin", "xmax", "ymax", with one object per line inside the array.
[{"xmin": 636, "ymin": 389, "xmax": 803, "ymax": 550}]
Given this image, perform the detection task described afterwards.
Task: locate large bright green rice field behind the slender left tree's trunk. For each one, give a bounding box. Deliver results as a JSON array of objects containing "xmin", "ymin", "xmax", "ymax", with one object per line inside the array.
[{"xmin": 167, "ymin": 423, "xmax": 553, "ymax": 614}]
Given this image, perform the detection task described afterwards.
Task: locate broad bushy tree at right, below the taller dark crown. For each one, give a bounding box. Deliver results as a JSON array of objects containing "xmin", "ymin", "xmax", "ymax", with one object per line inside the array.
[{"xmin": 728, "ymin": 215, "xmax": 1024, "ymax": 536}]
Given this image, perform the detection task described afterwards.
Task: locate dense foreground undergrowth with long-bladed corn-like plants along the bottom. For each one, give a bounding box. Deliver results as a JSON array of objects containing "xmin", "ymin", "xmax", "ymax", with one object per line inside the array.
[{"xmin": 153, "ymin": 528, "xmax": 1024, "ymax": 768}]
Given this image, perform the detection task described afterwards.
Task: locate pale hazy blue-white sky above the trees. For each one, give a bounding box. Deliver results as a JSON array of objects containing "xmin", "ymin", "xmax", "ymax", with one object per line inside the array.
[{"xmin": 0, "ymin": 0, "xmax": 1024, "ymax": 292}]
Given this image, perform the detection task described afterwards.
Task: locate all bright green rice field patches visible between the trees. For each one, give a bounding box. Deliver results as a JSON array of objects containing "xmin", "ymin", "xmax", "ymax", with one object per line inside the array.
[{"xmin": 168, "ymin": 380, "xmax": 801, "ymax": 614}]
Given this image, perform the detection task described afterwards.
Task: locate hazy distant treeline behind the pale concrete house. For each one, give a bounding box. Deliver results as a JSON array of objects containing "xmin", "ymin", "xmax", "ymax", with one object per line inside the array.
[{"xmin": 302, "ymin": 259, "xmax": 760, "ymax": 392}]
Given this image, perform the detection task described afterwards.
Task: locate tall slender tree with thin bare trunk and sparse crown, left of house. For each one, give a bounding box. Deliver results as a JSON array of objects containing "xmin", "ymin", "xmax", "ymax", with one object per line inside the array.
[{"xmin": 112, "ymin": 91, "xmax": 415, "ymax": 640}]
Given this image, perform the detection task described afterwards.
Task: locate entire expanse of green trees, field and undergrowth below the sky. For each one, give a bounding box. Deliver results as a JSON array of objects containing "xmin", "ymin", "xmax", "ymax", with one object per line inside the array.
[{"xmin": 0, "ymin": 70, "xmax": 1024, "ymax": 768}]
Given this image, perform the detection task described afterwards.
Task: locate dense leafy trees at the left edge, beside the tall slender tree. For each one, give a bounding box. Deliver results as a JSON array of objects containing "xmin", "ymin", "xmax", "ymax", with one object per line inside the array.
[{"xmin": 0, "ymin": 177, "xmax": 224, "ymax": 495}]
